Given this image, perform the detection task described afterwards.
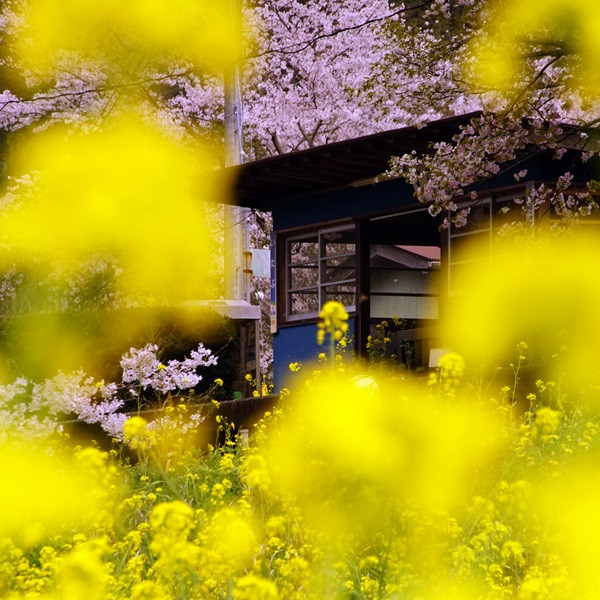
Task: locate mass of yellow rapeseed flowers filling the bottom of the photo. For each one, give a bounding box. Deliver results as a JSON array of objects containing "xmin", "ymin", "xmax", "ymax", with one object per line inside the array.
[{"xmin": 0, "ymin": 298, "xmax": 600, "ymax": 599}]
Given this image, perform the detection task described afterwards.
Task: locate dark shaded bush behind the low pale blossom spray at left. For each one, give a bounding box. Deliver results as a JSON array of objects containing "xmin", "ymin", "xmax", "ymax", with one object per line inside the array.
[{"xmin": 0, "ymin": 307, "xmax": 240, "ymax": 399}]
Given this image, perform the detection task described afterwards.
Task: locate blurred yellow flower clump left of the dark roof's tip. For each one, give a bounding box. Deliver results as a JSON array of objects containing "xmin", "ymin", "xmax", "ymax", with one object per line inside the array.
[{"xmin": 0, "ymin": 114, "xmax": 225, "ymax": 299}]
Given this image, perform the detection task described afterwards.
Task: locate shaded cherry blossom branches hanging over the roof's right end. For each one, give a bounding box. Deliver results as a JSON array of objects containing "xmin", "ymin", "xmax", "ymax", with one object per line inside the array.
[{"xmin": 390, "ymin": 0, "xmax": 600, "ymax": 226}]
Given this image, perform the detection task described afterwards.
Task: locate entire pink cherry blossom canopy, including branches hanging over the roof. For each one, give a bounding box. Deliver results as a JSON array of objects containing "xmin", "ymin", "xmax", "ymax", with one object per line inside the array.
[{"xmin": 0, "ymin": 0, "xmax": 600, "ymax": 382}]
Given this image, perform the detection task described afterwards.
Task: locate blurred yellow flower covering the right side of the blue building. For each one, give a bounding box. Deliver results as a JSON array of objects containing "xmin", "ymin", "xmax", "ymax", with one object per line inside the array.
[{"xmin": 444, "ymin": 230, "xmax": 600, "ymax": 400}]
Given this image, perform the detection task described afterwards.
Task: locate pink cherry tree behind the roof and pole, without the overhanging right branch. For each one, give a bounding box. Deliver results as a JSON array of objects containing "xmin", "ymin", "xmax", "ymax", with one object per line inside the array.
[{"xmin": 0, "ymin": 0, "xmax": 474, "ymax": 159}]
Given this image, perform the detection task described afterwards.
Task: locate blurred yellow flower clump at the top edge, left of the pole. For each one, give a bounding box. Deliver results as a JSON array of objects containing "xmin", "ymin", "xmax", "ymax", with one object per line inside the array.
[{"xmin": 12, "ymin": 0, "xmax": 239, "ymax": 71}]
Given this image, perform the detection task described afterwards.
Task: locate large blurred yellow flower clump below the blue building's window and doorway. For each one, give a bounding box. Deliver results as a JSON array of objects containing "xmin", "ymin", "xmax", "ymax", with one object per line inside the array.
[{"xmin": 265, "ymin": 371, "xmax": 499, "ymax": 536}]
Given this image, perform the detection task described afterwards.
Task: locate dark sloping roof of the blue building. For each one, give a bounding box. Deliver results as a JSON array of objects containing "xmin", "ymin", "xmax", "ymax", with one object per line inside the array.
[{"xmin": 230, "ymin": 113, "xmax": 479, "ymax": 210}]
